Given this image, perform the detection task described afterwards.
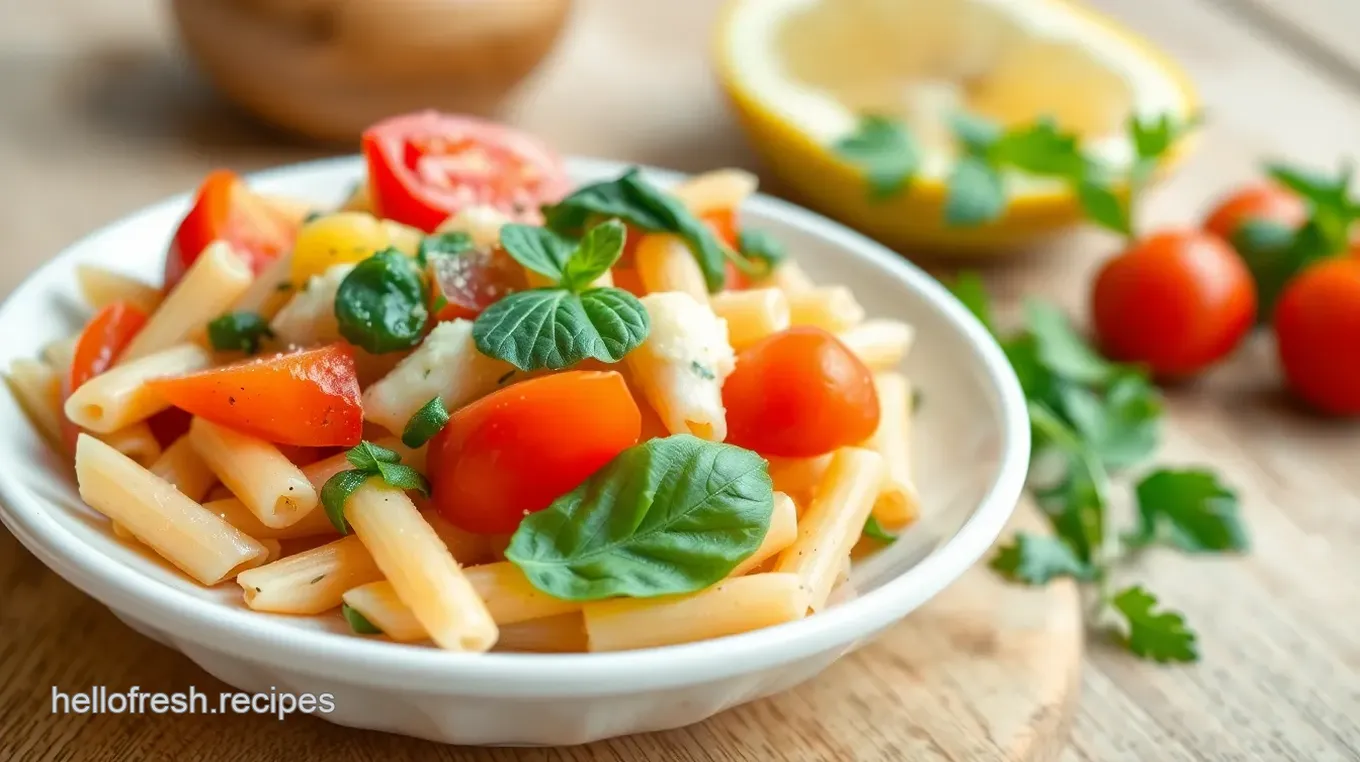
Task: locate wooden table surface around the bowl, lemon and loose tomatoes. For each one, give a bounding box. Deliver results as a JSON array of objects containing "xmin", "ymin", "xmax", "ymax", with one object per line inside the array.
[{"xmin": 0, "ymin": 0, "xmax": 1360, "ymax": 762}]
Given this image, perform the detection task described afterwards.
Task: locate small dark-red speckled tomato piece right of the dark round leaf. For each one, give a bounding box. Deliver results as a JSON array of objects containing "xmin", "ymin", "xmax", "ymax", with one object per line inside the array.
[{"xmin": 430, "ymin": 246, "xmax": 528, "ymax": 320}]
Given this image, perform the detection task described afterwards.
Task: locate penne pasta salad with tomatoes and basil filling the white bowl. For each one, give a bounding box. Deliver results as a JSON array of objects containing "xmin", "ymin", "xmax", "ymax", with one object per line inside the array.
[{"xmin": 7, "ymin": 113, "xmax": 918, "ymax": 652}]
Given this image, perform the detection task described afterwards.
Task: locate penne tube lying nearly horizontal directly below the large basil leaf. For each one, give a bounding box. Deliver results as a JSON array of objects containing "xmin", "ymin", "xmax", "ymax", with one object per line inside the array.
[{"xmin": 582, "ymin": 574, "xmax": 808, "ymax": 652}]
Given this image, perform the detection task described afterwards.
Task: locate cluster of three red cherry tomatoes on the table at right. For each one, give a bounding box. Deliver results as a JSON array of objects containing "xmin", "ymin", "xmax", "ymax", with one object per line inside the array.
[{"xmin": 1091, "ymin": 182, "xmax": 1360, "ymax": 415}]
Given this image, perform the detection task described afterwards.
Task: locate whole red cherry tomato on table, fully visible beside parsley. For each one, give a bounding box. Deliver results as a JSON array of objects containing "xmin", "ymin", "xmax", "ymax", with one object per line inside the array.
[{"xmin": 1091, "ymin": 230, "xmax": 1257, "ymax": 377}]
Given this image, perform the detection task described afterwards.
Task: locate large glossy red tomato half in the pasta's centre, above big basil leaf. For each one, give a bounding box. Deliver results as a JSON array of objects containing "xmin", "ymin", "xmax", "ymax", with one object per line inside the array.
[{"xmin": 428, "ymin": 370, "xmax": 642, "ymax": 535}]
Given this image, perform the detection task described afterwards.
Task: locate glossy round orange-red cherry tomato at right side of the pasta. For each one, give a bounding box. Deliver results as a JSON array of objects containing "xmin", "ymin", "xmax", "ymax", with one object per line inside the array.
[{"xmin": 722, "ymin": 328, "xmax": 879, "ymax": 457}]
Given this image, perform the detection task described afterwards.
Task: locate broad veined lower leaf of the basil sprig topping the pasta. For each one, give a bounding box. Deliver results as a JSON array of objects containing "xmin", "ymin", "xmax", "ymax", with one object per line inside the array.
[{"xmin": 472, "ymin": 288, "xmax": 651, "ymax": 370}]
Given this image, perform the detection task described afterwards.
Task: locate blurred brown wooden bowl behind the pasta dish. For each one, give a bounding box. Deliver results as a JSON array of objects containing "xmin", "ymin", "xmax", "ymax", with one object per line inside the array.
[{"xmin": 171, "ymin": 0, "xmax": 571, "ymax": 142}]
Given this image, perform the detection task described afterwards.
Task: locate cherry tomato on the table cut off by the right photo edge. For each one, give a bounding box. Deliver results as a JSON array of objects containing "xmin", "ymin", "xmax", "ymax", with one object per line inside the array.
[{"xmin": 1274, "ymin": 257, "xmax": 1360, "ymax": 415}]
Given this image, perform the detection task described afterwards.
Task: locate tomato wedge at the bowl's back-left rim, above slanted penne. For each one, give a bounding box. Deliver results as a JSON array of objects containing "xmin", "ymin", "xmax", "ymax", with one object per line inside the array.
[{"xmin": 165, "ymin": 169, "xmax": 298, "ymax": 290}]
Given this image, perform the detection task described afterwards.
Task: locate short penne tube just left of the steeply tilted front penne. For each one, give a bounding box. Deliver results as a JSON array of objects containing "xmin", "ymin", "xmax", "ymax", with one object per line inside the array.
[{"xmin": 237, "ymin": 536, "xmax": 382, "ymax": 614}]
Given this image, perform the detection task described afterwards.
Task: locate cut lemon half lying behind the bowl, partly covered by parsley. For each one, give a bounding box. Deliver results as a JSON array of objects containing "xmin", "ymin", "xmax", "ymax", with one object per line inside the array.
[{"xmin": 715, "ymin": 0, "xmax": 1198, "ymax": 253}]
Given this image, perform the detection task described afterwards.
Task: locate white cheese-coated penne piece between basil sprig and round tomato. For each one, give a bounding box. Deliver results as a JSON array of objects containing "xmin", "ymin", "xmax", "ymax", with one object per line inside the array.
[{"xmin": 624, "ymin": 293, "xmax": 736, "ymax": 442}]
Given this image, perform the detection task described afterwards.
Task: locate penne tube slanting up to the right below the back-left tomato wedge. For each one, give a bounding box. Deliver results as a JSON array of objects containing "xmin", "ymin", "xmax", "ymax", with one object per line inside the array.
[{"xmin": 118, "ymin": 241, "xmax": 254, "ymax": 365}]
